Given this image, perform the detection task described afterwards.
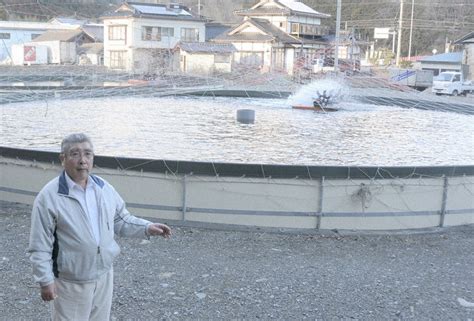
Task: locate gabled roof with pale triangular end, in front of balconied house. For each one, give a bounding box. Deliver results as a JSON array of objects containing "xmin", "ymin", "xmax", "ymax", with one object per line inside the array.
[{"xmin": 214, "ymin": 18, "xmax": 301, "ymax": 44}]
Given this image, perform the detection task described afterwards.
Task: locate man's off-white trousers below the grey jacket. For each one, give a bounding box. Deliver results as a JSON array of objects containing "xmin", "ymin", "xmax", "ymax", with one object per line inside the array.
[{"xmin": 51, "ymin": 269, "xmax": 114, "ymax": 321}]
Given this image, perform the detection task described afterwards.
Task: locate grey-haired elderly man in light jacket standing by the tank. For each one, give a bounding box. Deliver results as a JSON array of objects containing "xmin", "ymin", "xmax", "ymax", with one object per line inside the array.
[{"xmin": 28, "ymin": 134, "xmax": 171, "ymax": 321}]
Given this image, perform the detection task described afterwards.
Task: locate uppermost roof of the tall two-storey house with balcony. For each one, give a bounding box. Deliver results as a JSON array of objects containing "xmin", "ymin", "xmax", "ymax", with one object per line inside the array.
[{"xmin": 235, "ymin": 0, "xmax": 331, "ymax": 18}]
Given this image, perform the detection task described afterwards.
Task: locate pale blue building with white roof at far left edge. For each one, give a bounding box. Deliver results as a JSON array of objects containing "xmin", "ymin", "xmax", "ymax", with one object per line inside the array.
[{"xmin": 0, "ymin": 21, "xmax": 79, "ymax": 63}]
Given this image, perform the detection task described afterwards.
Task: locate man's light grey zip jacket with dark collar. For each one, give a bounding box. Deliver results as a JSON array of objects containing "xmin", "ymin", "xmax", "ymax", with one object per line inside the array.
[{"xmin": 28, "ymin": 171, "xmax": 151, "ymax": 286}]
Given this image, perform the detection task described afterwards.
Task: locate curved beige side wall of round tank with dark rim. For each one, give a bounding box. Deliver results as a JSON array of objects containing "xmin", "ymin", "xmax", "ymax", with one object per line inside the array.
[{"xmin": 0, "ymin": 147, "xmax": 474, "ymax": 230}]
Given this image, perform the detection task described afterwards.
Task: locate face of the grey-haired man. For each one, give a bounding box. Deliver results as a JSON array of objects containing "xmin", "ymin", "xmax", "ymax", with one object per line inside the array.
[{"xmin": 60, "ymin": 142, "xmax": 94, "ymax": 183}]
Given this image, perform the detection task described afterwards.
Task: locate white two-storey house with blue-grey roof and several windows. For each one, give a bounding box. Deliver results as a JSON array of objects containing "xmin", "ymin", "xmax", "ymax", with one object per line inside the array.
[{"xmin": 102, "ymin": 2, "xmax": 205, "ymax": 74}]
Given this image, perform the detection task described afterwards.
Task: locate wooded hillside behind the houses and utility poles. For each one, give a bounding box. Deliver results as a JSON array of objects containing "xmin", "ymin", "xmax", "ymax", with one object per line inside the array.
[{"xmin": 0, "ymin": 0, "xmax": 474, "ymax": 55}]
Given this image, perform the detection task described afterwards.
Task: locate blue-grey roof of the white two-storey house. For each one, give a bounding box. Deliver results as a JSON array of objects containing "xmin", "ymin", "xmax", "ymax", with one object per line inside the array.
[{"xmin": 102, "ymin": 2, "xmax": 202, "ymax": 20}]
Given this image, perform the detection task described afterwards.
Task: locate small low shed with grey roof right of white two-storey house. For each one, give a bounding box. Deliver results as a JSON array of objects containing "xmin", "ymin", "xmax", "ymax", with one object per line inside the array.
[{"xmin": 175, "ymin": 42, "xmax": 237, "ymax": 75}]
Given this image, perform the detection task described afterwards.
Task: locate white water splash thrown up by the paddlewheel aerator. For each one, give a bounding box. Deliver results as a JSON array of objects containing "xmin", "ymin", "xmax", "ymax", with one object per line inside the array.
[{"xmin": 288, "ymin": 78, "xmax": 349, "ymax": 106}]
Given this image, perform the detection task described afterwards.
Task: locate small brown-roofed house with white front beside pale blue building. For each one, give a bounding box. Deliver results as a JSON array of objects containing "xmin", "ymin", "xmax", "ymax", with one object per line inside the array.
[{"xmin": 31, "ymin": 29, "xmax": 94, "ymax": 64}]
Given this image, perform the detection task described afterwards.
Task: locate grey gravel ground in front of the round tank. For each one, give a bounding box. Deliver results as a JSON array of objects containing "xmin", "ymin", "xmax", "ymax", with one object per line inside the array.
[{"xmin": 0, "ymin": 202, "xmax": 474, "ymax": 320}]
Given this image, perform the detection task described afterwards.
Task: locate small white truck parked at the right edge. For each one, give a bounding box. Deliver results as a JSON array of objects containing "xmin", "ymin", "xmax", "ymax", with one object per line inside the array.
[{"xmin": 431, "ymin": 71, "xmax": 474, "ymax": 96}]
